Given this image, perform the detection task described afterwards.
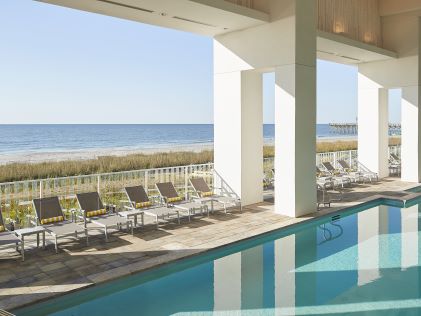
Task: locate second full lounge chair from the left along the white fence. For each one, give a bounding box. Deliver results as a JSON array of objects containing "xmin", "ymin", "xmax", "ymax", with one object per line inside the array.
[{"xmin": 76, "ymin": 192, "xmax": 133, "ymax": 241}]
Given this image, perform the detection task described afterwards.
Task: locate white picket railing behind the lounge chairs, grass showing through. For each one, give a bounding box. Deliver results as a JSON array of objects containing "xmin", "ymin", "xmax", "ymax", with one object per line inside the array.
[{"xmin": 0, "ymin": 146, "xmax": 400, "ymax": 227}]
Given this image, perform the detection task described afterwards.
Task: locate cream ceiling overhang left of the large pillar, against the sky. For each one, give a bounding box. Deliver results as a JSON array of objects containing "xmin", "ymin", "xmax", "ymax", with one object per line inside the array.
[{"xmin": 38, "ymin": 0, "xmax": 269, "ymax": 36}]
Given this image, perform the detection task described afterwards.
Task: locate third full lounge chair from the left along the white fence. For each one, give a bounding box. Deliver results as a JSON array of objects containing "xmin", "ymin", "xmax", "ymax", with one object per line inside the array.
[{"xmin": 123, "ymin": 185, "xmax": 185, "ymax": 228}]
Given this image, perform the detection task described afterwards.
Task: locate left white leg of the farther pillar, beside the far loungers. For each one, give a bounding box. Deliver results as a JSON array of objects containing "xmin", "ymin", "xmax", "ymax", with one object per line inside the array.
[{"xmin": 358, "ymin": 74, "xmax": 389, "ymax": 178}]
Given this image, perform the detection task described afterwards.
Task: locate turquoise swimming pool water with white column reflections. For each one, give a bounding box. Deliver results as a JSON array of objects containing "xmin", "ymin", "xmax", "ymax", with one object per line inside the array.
[{"xmin": 14, "ymin": 203, "xmax": 421, "ymax": 316}]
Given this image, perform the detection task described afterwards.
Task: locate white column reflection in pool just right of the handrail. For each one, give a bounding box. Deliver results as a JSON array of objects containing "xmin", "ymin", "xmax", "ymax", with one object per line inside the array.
[{"xmin": 357, "ymin": 206, "xmax": 381, "ymax": 285}]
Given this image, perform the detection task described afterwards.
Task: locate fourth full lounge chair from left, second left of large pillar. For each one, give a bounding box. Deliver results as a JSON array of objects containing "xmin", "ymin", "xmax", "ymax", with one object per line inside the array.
[{"xmin": 155, "ymin": 182, "xmax": 209, "ymax": 221}]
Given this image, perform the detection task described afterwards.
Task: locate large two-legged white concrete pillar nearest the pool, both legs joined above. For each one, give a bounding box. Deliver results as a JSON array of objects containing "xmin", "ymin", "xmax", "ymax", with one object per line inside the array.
[{"xmin": 214, "ymin": 0, "xmax": 316, "ymax": 212}]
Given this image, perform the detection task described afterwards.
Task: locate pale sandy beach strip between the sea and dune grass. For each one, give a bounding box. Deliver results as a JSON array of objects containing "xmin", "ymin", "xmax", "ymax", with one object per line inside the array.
[{"xmin": 0, "ymin": 137, "xmax": 356, "ymax": 165}]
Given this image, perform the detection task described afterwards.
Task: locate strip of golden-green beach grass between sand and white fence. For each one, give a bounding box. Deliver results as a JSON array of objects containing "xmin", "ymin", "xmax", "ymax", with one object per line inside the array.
[{"xmin": 0, "ymin": 137, "xmax": 400, "ymax": 182}]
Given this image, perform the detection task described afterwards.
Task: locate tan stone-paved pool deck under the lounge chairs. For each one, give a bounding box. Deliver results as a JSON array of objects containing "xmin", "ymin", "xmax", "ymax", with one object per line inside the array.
[{"xmin": 0, "ymin": 178, "xmax": 420, "ymax": 310}]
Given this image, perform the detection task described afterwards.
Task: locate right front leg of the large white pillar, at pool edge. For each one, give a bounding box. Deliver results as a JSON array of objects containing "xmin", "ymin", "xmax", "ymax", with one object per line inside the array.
[{"xmin": 275, "ymin": 1, "xmax": 316, "ymax": 217}]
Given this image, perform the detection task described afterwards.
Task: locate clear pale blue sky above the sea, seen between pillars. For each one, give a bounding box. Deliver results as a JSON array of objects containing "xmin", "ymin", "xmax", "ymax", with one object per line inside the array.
[{"xmin": 0, "ymin": 0, "xmax": 400, "ymax": 124}]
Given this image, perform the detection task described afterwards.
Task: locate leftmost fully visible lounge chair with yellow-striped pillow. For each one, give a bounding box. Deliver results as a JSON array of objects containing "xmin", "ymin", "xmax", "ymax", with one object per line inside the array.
[{"xmin": 32, "ymin": 196, "xmax": 89, "ymax": 253}]
